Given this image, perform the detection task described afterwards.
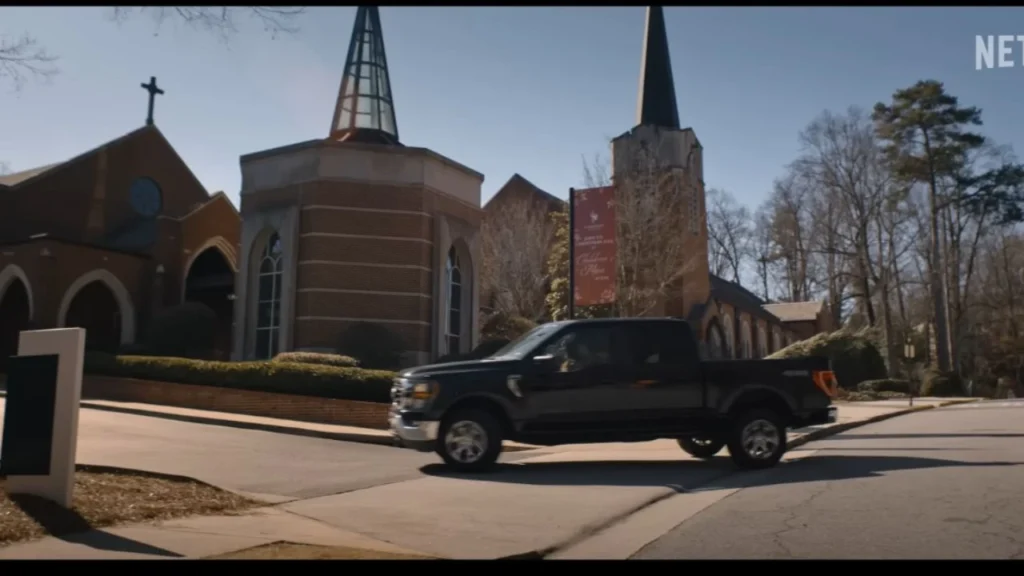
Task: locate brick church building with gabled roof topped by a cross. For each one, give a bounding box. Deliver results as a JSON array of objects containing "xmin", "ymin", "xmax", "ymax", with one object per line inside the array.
[{"xmin": 0, "ymin": 118, "xmax": 241, "ymax": 370}]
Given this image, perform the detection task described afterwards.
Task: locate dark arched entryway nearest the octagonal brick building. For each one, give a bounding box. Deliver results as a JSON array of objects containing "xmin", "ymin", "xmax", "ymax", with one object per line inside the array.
[{"xmin": 184, "ymin": 247, "xmax": 234, "ymax": 360}]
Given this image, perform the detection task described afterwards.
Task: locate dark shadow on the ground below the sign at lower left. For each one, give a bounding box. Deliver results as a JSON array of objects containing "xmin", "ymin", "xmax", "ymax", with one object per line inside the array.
[{"xmin": 9, "ymin": 494, "xmax": 183, "ymax": 558}]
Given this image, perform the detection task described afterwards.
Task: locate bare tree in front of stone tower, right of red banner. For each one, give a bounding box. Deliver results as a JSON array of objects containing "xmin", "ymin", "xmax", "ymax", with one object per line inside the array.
[{"xmin": 614, "ymin": 135, "xmax": 701, "ymax": 317}]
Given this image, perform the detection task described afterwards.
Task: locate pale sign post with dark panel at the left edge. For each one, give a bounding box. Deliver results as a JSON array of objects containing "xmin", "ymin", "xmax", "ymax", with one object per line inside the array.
[{"xmin": 0, "ymin": 328, "xmax": 85, "ymax": 508}]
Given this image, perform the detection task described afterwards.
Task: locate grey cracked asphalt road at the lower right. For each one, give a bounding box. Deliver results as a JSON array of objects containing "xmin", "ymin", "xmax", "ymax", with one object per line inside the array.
[{"xmin": 633, "ymin": 400, "xmax": 1024, "ymax": 559}]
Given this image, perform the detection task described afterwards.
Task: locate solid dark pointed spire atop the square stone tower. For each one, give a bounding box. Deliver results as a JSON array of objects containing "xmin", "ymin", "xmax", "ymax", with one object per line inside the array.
[{"xmin": 637, "ymin": 6, "xmax": 680, "ymax": 130}]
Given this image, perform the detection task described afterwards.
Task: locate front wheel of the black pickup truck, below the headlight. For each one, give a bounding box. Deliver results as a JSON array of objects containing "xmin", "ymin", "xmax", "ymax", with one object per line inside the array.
[{"xmin": 437, "ymin": 409, "xmax": 502, "ymax": 472}]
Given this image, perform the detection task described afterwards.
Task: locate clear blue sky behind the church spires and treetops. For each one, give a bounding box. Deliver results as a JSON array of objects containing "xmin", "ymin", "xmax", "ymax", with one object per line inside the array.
[{"xmin": 0, "ymin": 7, "xmax": 1024, "ymax": 208}]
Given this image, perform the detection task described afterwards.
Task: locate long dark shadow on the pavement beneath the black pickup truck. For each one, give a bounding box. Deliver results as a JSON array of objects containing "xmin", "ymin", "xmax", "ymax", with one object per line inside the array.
[{"xmin": 420, "ymin": 454, "xmax": 1021, "ymax": 492}]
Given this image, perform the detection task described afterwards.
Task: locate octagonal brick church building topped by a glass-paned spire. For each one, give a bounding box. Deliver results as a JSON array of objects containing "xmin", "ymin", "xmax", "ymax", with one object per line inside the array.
[{"xmin": 232, "ymin": 6, "xmax": 483, "ymax": 365}]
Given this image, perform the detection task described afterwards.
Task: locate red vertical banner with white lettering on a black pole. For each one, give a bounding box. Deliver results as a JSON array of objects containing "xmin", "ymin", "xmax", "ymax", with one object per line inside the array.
[{"xmin": 572, "ymin": 187, "xmax": 615, "ymax": 306}]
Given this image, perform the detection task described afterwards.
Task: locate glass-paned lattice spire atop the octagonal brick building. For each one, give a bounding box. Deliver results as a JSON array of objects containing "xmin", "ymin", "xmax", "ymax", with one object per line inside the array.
[{"xmin": 329, "ymin": 6, "xmax": 400, "ymax": 146}]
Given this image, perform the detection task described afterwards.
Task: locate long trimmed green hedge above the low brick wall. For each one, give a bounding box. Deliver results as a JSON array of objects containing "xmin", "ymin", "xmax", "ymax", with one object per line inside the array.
[{"xmin": 85, "ymin": 353, "xmax": 394, "ymax": 404}]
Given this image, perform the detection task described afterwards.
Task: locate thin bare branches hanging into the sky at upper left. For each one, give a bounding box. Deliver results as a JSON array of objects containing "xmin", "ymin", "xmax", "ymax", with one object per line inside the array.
[{"xmin": 0, "ymin": 6, "xmax": 305, "ymax": 90}]
